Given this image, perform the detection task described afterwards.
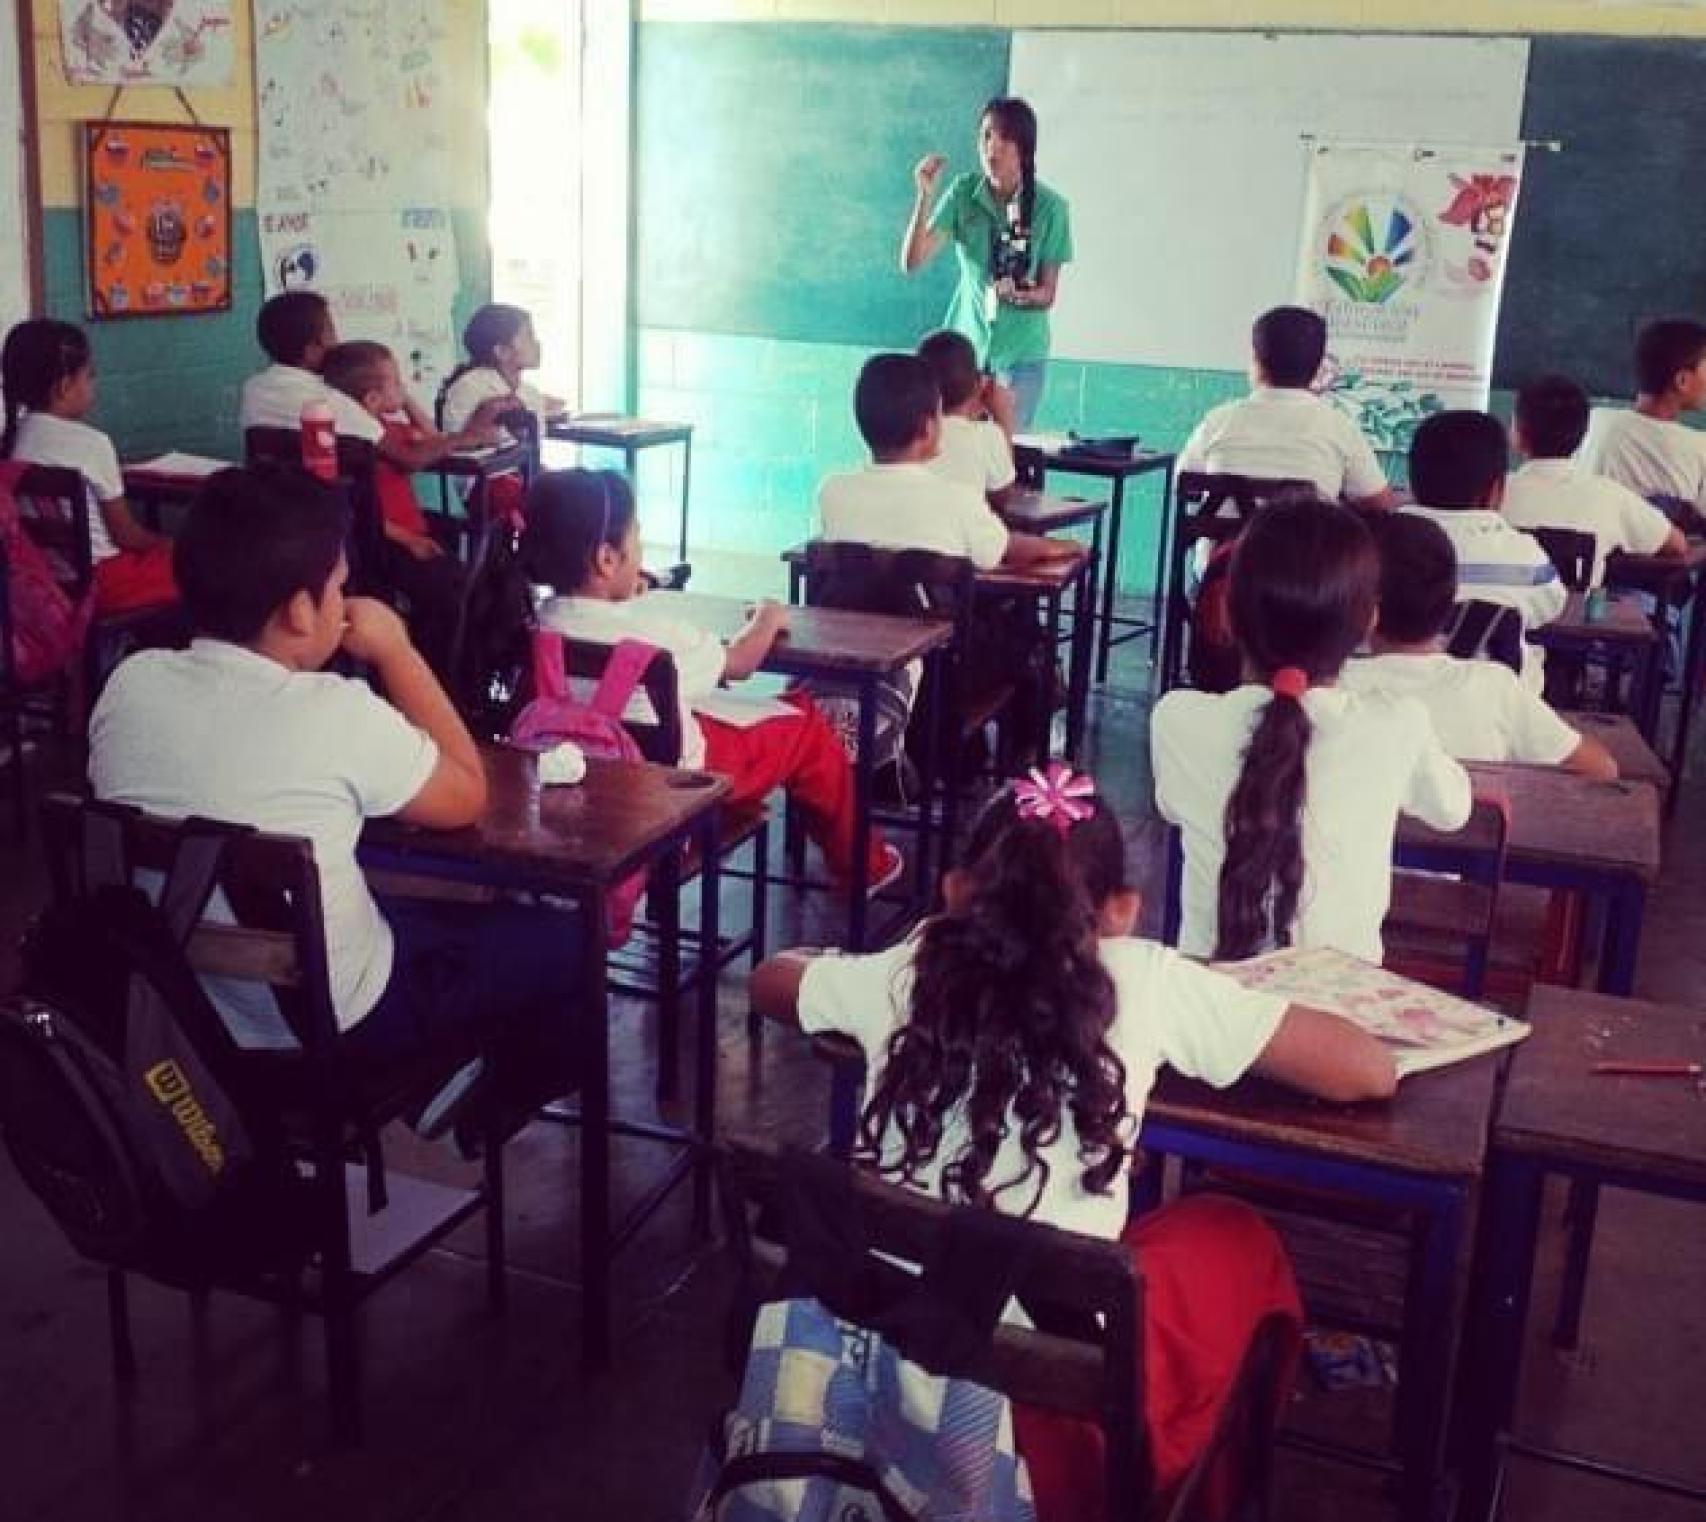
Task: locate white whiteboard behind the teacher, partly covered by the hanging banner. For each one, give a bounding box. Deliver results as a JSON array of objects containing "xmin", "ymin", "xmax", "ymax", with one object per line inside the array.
[{"xmin": 1012, "ymin": 31, "xmax": 1529, "ymax": 370}]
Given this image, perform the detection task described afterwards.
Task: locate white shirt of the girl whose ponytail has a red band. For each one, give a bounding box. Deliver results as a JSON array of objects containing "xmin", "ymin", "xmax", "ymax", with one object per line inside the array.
[{"xmin": 1150, "ymin": 686, "xmax": 1471, "ymax": 962}]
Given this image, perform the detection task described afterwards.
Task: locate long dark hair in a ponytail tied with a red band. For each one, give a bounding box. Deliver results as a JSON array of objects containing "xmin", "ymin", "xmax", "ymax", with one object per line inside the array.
[{"xmin": 1215, "ymin": 500, "xmax": 1380, "ymax": 961}]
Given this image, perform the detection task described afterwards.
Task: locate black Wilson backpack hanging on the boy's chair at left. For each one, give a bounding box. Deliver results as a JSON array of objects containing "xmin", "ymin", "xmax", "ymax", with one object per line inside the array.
[{"xmin": 0, "ymin": 805, "xmax": 305, "ymax": 1285}]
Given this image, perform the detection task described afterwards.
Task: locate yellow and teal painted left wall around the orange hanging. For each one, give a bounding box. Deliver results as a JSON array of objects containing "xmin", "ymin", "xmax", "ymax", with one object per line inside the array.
[{"xmin": 23, "ymin": 0, "xmax": 490, "ymax": 457}]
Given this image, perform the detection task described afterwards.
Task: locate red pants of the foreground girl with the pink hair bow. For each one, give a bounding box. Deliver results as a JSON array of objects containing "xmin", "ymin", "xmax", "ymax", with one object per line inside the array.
[{"xmin": 1013, "ymin": 1194, "xmax": 1303, "ymax": 1522}]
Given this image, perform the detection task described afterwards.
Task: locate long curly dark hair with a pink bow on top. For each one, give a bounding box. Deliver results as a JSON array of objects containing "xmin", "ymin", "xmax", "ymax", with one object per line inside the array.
[{"xmin": 860, "ymin": 788, "xmax": 1126, "ymax": 1215}]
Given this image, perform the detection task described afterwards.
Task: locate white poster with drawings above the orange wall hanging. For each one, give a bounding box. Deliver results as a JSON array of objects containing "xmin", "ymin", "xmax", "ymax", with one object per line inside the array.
[{"xmin": 60, "ymin": 0, "xmax": 234, "ymax": 85}]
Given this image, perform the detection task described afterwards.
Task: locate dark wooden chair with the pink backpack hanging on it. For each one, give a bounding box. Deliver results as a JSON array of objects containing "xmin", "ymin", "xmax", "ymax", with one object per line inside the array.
[{"xmin": 542, "ymin": 624, "xmax": 769, "ymax": 1099}]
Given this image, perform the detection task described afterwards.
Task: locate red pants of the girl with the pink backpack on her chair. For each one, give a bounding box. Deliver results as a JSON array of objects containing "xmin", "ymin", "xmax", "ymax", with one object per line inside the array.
[{"xmin": 699, "ymin": 693, "xmax": 882, "ymax": 882}]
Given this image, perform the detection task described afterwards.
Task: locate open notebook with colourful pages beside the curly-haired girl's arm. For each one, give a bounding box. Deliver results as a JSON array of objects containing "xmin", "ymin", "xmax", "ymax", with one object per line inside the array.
[{"xmin": 1215, "ymin": 947, "xmax": 1529, "ymax": 1078}]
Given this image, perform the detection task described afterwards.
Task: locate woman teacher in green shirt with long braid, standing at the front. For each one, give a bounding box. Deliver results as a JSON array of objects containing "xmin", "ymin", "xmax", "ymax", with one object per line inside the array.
[{"xmin": 901, "ymin": 96, "xmax": 1071, "ymax": 428}]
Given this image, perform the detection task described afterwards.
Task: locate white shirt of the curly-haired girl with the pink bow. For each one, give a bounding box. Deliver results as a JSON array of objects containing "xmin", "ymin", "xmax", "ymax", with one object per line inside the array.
[{"xmin": 798, "ymin": 933, "xmax": 1286, "ymax": 1240}]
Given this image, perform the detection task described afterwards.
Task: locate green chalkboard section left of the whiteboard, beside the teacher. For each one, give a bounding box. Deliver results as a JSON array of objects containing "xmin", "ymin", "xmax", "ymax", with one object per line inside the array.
[{"xmin": 635, "ymin": 22, "xmax": 1010, "ymax": 348}]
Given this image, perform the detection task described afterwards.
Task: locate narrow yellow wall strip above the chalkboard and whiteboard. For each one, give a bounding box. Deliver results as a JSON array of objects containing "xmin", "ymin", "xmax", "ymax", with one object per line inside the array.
[{"xmin": 640, "ymin": 0, "xmax": 1706, "ymax": 38}]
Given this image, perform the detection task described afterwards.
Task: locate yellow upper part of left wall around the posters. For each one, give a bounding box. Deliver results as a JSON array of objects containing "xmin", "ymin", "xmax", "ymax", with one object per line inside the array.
[{"xmin": 31, "ymin": 0, "xmax": 486, "ymax": 206}]
